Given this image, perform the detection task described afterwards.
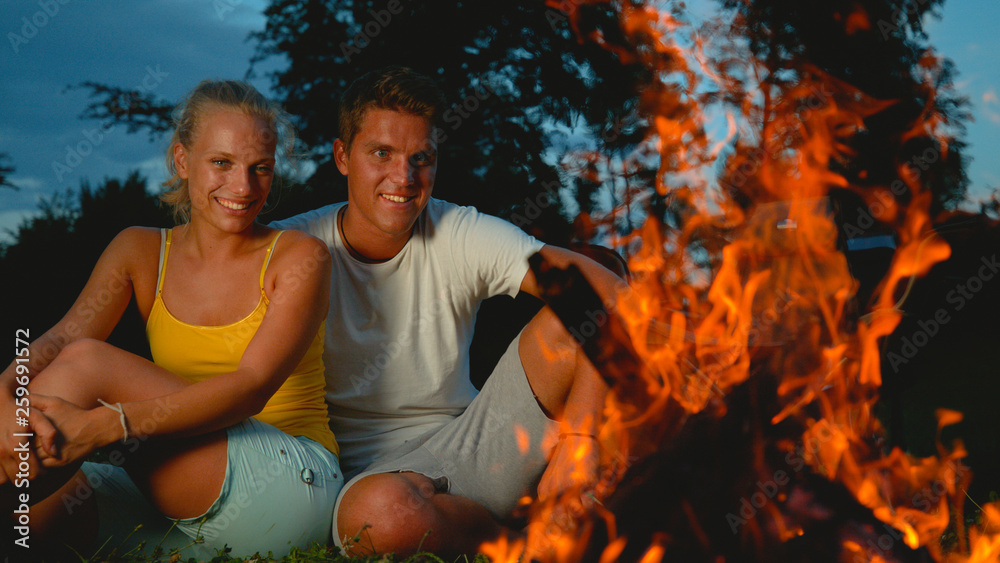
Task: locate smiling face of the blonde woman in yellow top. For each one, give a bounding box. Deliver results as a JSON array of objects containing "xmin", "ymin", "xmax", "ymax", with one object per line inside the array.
[{"xmin": 174, "ymin": 108, "xmax": 275, "ymax": 233}]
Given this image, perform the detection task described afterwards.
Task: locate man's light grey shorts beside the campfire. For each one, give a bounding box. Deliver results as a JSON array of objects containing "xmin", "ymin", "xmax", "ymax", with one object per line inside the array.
[{"xmin": 333, "ymin": 335, "xmax": 558, "ymax": 546}]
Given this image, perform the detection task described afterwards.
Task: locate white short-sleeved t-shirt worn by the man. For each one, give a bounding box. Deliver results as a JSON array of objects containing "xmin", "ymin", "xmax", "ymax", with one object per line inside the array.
[{"xmin": 272, "ymin": 198, "xmax": 543, "ymax": 475}]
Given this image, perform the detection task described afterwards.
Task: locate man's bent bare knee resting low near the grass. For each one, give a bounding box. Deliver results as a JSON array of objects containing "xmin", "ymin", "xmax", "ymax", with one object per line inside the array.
[{"xmin": 337, "ymin": 473, "xmax": 439, "ymax": 555}]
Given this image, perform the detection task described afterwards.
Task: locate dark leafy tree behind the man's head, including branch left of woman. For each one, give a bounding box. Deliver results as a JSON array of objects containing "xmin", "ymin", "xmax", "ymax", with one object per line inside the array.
[{"xmin": 72, "ymin": 0, "xmax": 643, "ymax": 242}]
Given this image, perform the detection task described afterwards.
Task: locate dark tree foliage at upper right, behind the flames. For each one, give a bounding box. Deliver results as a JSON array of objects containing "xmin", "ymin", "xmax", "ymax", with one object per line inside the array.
[{"xmin": 721, "ymin": 0, "xmax": 971, "ymax": 216}]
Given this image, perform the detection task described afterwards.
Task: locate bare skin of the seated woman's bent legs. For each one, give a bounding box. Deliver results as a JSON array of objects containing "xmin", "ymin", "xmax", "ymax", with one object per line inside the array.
[{"xmin": 29, "ymin": 340, "xmax": 227, "ymax": 548}]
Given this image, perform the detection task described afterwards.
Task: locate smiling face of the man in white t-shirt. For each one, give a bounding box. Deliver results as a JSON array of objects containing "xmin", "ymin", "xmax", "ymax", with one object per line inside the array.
[{"xmin": 333, "ymin": 108, "xmax": 437, "ymax": 260}]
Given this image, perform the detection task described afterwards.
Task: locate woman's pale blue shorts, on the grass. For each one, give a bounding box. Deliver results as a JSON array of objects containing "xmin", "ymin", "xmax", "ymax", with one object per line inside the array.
[{"xmin": 83, "ymin": 418, "xmax": 344, "ymax": 559}]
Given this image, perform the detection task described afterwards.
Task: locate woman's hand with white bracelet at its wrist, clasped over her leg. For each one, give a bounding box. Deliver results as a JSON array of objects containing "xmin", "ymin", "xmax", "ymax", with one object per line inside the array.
[{"xmin": 31, "ymin": 394, "xmax": 118, "ymax": 467}]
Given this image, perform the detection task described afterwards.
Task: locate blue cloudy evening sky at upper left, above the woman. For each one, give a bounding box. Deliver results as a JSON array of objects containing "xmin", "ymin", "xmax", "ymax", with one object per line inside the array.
[{"xmin": 0, "ymin": 0, "xmax": 267, "ymax": 225}]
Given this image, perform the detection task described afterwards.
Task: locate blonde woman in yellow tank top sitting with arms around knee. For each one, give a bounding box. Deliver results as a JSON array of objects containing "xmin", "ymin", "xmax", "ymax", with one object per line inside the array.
[{"xmin": 0, "ymin": 82, "xmax": 343, "ymax": 555}]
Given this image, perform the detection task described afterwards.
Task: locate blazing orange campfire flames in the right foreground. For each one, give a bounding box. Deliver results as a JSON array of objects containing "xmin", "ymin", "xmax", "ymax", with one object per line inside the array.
[{"xmin": 483, "ymin": 0, "xmax": 1000, "ymax": 563}]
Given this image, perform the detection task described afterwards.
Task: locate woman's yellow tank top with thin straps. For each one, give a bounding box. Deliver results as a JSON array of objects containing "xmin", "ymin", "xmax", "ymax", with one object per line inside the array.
[{"xmin": 146, "ymin": 229, "xmax": 340, "ymax": 455}]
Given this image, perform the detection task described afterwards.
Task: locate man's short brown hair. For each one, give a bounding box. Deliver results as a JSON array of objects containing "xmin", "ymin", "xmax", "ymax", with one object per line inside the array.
[{"xmin": 338, "ymin": 66, "xmax": 445, "ymax": 150}]
